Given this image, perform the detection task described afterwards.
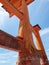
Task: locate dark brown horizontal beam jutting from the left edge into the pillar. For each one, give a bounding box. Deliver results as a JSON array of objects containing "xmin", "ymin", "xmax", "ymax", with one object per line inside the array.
[{"xmin": 0, "ymin": 30, "xmax": 23, "ymax": 51}]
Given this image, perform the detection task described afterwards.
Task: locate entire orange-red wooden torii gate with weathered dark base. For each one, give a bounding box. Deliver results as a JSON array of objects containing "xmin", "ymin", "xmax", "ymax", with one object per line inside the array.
[{"xmin": 0, "ymin": 0, "xmax": 49, "ymax": 65}]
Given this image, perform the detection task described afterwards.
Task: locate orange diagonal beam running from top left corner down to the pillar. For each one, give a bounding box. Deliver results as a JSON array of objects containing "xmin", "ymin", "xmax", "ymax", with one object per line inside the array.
[{"xmin": 0, "ymin": 0, "xmax": 23, "ymax": 19}]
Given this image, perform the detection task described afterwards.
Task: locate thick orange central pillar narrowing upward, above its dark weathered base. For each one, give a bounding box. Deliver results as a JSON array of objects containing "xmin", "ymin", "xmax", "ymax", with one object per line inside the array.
[{"xmin": 18, "ymin": 0, "xmax": 35, "ymax": 52}]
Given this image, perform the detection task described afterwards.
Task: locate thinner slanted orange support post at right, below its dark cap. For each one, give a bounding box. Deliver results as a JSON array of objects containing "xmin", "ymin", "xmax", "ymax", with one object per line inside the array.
[{"xmin": 32, "ymin": 24, "xmax": 48, "ymax": 65}]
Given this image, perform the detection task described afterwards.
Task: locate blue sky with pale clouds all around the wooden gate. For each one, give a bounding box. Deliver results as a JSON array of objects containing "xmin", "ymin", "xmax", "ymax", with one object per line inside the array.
[{"xmin": 0, "ymin": 0, "xmax": 49, "ymax": 65}]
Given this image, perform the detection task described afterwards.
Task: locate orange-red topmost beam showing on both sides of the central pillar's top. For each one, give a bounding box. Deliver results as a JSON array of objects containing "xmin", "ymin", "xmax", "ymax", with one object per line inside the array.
[{"xmin": 9, "ymin": 0, "xmax": 34, "ymax": 10}]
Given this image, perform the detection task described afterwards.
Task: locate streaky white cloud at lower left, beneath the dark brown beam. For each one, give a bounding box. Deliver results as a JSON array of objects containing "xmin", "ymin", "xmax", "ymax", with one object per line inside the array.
[{"xmin": 0, "ymin": 51, "xmax": 18, "ymax": 64}]
